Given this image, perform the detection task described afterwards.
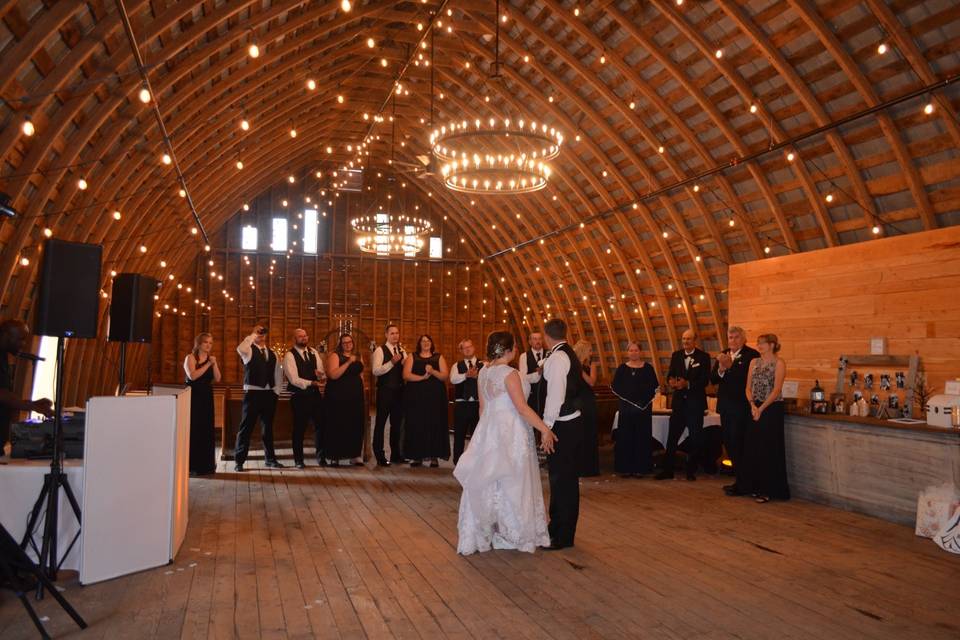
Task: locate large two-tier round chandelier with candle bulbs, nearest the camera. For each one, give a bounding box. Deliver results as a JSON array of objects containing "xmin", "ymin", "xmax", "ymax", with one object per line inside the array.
[{"xmin": 430, "ymin": 118, "xmax": 563, "ymax": 194}]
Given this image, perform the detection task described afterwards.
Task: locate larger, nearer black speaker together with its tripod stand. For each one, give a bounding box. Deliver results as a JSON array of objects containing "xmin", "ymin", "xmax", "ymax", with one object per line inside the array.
[{"xmin": 20, "ymin": 239, "xmax": 103, "ymax": 598}]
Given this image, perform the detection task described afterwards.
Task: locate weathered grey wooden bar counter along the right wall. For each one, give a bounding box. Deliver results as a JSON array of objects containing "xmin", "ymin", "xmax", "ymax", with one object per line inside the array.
[{"xmin": 784, "ymin": 414, "xmax": 960, "ymax": 526}]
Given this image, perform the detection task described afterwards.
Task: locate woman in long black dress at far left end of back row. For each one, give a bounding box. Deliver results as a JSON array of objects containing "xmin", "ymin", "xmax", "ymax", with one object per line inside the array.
[{"xmin": 183, "ymin": 332, "xmax": 220, "ymax": 476}]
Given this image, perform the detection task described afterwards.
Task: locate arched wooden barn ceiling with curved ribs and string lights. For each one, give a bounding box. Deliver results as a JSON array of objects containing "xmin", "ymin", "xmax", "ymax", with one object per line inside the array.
[{"xmin": 0, "ymin": 0, "xmax": 960, "ymax": 380}]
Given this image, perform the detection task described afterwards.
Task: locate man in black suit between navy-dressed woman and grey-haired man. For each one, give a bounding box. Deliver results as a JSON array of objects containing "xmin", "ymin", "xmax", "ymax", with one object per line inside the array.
[{"xmin": 656, "ymin": 329, "xmax": 710, "ymax": 480}]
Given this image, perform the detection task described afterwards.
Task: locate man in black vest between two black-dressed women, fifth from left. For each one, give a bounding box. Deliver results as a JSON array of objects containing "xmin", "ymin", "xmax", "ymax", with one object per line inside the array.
[{"xmin": 370, "ymin": 324, "xmax": 407, "ymax": 467}]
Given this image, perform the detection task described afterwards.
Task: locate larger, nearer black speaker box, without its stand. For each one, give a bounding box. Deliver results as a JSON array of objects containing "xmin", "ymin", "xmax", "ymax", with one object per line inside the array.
[{"xmin": 35, "ymin": 238, "xmax": 103, "ymax": 338}]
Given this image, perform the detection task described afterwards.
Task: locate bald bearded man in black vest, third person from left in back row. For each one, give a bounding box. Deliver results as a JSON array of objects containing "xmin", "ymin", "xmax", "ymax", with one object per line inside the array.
[{"xmin": 283, "ymin": 329, "xmax": 327, "ymax": 469}]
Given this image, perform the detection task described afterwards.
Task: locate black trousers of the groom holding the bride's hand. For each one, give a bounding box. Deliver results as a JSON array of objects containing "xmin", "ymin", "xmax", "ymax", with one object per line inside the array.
[{"xmin": 547, "ymin": 417, "xmax": 583, "ymax": 547}]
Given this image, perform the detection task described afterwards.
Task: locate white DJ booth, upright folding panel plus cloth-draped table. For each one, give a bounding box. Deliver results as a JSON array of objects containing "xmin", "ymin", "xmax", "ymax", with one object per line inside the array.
[{"xmin": 0, "ymin": 387, "xmax": 190, "ymax": 584}]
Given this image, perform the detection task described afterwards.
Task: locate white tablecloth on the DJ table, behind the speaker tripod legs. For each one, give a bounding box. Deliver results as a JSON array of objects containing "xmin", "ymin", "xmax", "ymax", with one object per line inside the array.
[{"xmin": 0, "ymin": 458, "xmax": 83, "ymax": 571}]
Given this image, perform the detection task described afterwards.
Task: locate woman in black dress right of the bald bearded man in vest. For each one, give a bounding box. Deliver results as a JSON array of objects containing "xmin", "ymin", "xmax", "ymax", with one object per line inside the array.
[{"xmin": 324, "ymin": 333, "xmax": 366, "ymax": 467}]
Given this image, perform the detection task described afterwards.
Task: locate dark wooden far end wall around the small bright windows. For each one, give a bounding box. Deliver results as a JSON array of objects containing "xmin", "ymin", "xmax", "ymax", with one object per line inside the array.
[{"xmin": 152, "ymin": 183, "xmax": 511, "ymax": 382}]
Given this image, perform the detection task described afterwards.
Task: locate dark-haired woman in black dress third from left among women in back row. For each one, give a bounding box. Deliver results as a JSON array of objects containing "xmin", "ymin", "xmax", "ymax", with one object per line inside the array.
[{"xmin": 403, "ymin": 335, "xmax": 450, "ymax": 467}]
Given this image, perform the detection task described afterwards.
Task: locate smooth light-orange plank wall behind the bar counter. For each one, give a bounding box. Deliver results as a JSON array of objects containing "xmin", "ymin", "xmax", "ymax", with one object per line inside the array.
[{"xmin": 729, "ymin": 227, "xmax": 960, "ymax": 410}]
